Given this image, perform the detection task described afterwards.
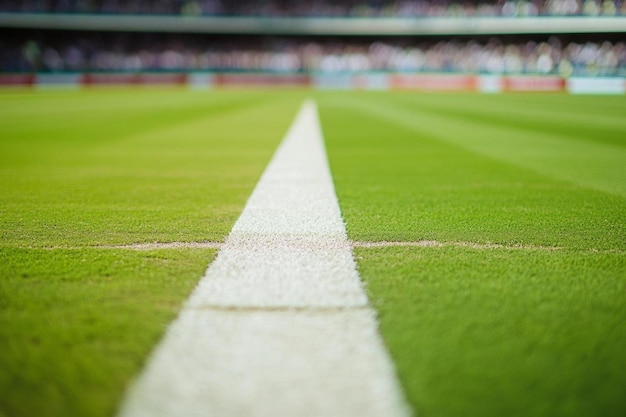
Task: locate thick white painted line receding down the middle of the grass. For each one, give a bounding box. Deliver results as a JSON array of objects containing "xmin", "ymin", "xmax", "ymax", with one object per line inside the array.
[{"xmin": 121, "ymin": 101, "xmax": 410, "ymax": 417}]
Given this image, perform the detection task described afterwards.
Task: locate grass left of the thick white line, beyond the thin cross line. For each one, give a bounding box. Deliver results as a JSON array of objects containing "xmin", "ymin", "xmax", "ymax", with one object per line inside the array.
[{"xmin": 0, "ymin": 91, "xmax": 302, "ymax": 246}]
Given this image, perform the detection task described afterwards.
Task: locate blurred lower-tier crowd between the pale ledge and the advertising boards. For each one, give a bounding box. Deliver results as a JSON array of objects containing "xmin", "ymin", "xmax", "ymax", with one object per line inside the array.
[{"xmin": 0, "ymin": 35, "xmax": 626, "ymax": 77}]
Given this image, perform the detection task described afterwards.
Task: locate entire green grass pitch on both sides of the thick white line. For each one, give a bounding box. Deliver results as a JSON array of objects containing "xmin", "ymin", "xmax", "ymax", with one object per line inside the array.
[{"xmin": 0, "ymin": 89, "xmax": 626, "ymax": 417}]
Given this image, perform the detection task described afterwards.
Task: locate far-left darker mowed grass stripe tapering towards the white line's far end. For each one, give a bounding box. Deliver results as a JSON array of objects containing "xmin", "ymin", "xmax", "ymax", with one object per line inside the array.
[{"xmin": 0, "ymin": 89, "xmax": 268, "ymax": 161}]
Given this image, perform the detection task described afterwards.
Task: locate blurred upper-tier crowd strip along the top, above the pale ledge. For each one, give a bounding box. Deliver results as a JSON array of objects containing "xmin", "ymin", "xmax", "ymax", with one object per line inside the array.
[{"xmin": 0, "ymin": 0, "xmax": 626, "ymax": 18}]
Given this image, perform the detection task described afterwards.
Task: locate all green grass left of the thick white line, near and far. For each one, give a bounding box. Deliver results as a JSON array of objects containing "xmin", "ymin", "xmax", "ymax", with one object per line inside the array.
[{"xmin": 0, "ymin": 89, "xmax": 300, "ymax": 417}]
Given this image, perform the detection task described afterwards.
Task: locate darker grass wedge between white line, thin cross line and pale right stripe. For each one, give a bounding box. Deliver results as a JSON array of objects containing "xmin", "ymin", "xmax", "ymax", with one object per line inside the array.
[{"xmin": 321, "ymin": 95, "xmax": 626, "ymax": 251}]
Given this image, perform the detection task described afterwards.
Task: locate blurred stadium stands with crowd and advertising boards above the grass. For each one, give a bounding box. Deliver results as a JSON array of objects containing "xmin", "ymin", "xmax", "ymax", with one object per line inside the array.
[{"xmin": 0, "ymin": 0, "xmax": 626, "ymax": 93}]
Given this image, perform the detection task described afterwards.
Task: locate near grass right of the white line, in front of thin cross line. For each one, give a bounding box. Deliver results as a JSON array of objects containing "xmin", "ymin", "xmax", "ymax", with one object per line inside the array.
[{"xmin": 357, "ymin": 248, "xmax": 626, "ymax": 417}]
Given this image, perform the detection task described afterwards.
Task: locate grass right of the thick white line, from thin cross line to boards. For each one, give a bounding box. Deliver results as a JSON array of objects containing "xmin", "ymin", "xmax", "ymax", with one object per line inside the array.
[{"xmin": 321, "ymin": 95, "xmax": 626, "ymax": 249}]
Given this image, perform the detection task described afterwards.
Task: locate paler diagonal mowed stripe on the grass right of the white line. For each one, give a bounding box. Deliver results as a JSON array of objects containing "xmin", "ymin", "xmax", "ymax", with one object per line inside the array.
[{"xmin": 330, "ymin": 96, "xmax": 626, "ymax": 197}]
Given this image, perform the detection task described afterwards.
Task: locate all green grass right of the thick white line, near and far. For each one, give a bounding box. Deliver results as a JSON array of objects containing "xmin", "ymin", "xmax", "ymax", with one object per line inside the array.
[{"xmin": 320, "ymin": 94, "xmax": 626, "ymax": 417}]
